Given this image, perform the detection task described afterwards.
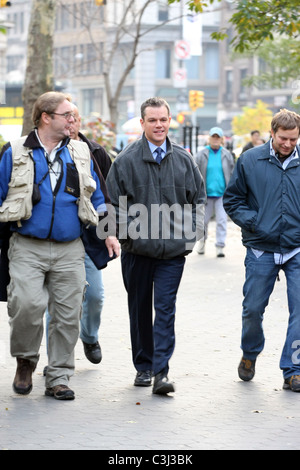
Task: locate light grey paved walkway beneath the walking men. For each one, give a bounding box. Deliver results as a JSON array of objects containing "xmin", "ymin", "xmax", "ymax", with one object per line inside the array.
[{"xmin": 0, "ymin": 222, "xmax": 300, "ymax": 455}]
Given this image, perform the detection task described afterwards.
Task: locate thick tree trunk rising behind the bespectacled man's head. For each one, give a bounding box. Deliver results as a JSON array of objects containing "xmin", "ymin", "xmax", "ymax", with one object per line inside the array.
[{"xmin": 22, "ymin": 0, "xmax": 56, "ymax": 135}]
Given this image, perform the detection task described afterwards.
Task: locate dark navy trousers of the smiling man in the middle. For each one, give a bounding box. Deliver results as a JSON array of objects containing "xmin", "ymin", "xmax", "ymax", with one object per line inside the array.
[{"xmin": 121, "ymin": 251, "xmax": 185, "ymax": 375}]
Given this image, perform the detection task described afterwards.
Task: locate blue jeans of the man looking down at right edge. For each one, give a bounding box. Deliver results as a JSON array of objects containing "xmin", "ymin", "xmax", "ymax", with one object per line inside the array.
[{"xmin": 241, "ymin": 248, "xmax": 300, "ymax": 378}]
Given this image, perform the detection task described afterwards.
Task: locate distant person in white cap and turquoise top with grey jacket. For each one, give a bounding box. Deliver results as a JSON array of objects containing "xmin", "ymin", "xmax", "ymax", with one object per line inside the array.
[{"xmin": 195, "ymin": 127, "xmax": 234, "ymax": 258}]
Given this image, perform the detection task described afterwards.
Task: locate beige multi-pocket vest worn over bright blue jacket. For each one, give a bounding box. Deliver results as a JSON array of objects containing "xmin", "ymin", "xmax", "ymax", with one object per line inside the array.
[{"xmin": 0, "ymin": 136, "xmax": 99, "ymax": 226}]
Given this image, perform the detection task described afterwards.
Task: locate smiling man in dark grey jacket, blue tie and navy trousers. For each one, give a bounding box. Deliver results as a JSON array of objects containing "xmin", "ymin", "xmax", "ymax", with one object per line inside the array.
[{"xmin": 107, "ymin": 97, "xmax": 205, "ymax": 394}]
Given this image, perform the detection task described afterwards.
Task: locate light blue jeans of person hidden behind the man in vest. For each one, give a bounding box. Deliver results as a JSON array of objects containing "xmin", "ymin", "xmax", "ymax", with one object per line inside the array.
[{"xmin": 46, "ymin": 254, "xmax": 104, "ymax": 344}]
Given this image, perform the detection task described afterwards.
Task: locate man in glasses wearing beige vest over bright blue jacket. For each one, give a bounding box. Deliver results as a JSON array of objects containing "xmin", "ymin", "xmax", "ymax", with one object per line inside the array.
[{"xmin": 0, "ymin": 92, "xmax": 118, "ymax": 400}]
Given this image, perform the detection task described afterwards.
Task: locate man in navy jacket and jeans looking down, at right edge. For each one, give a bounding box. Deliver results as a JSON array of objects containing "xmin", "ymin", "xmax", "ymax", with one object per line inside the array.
[{"xmin": 224, "ymin": 109, "xmax": 300, "ymax": 392}]
